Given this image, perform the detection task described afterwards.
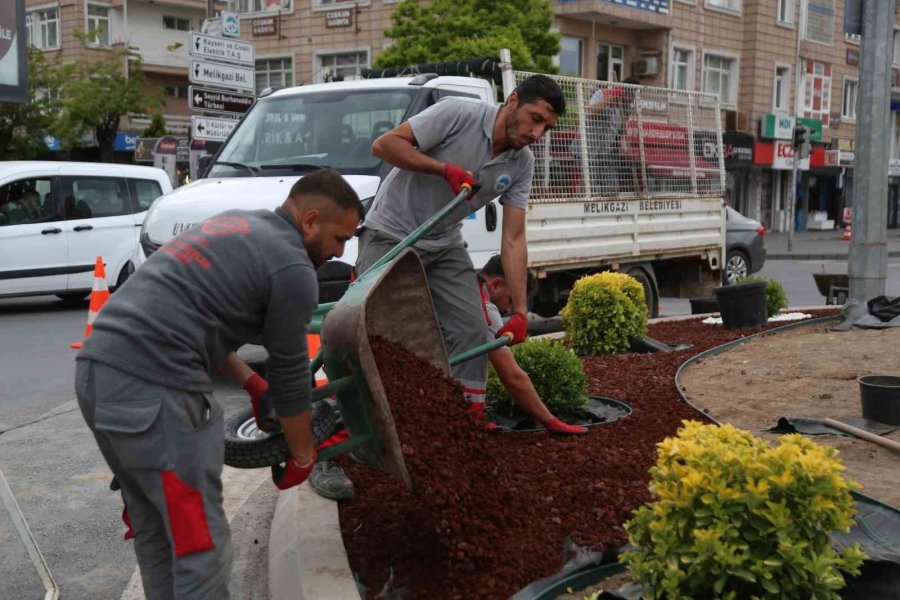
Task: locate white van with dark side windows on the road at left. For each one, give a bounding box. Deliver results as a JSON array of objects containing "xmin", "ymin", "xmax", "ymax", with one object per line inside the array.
[{"xmin": 0, "ymin": 161, "xmax": 172, "ymax": 299}]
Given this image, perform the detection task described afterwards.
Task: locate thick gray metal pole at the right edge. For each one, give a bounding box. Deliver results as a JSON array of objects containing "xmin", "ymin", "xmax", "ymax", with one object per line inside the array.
[{"xmin": 844, "ymin": 0, "xmax": 896, "ymax": 326}]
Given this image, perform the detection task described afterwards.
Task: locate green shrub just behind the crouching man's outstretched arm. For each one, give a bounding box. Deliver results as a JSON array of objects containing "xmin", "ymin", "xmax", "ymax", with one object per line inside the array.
[{"xmin": 486, "ymin": 340, "xmax": 588, "ymax": 414}]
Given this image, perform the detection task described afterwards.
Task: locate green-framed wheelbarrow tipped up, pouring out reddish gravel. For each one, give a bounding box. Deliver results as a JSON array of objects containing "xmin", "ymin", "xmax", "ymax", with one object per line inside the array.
[{"xmin": 226, "ymin": 189, "xmax": 510, "ymax": 491}]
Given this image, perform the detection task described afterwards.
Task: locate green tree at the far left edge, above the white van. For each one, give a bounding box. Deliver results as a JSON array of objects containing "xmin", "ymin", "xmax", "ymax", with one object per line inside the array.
[{"xmin": 0, "ymin": 46, "xmax": 60, "ymax": 160}]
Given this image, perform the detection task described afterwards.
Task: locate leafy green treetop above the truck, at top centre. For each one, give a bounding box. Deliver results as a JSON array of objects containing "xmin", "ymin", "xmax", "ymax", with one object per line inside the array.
[{"xmin": 375, "ymin": 0, "xmax": 559, "ymax": 73}]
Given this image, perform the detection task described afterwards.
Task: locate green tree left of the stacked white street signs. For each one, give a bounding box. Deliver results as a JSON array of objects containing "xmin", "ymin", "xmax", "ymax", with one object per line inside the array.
[{"xmin": 54, "ymin": 34, "xmax": 161, "ymax": 162}]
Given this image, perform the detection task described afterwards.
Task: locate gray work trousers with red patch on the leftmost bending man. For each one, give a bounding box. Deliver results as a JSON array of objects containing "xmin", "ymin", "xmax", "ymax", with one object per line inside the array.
[{"xmin": 75, "ymin": 360, "xmax": 232, "ymax": 600}]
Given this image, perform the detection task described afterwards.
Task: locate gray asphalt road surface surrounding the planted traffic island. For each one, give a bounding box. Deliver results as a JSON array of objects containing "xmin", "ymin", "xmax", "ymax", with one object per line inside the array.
[{"xmin": 0, "ymin": 261, "xmax": 900, "ymax": 600}]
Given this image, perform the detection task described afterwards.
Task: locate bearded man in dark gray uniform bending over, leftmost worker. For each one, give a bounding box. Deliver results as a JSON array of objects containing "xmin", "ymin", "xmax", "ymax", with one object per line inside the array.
[{"xmin": 75, "ymin": 170, "xmax": 364, "ymax": 600}]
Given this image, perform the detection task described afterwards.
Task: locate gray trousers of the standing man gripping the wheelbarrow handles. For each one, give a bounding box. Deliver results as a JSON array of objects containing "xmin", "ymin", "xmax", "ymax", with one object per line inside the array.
[{"xmin": 356, "ymin": 228, "xmax": 488, "ymax": 402}]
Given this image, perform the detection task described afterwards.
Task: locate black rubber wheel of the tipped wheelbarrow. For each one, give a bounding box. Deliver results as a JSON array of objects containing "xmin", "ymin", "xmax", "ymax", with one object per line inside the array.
[{"xmin": 225, "ymin": 408, "xmax": 291, "ymax": 469}]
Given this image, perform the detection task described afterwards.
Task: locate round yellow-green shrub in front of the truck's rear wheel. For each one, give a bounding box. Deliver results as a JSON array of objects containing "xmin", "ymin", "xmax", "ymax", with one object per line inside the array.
[{"xmin": 562, "ymin": 272, "xmax": 647, "ymax": 356}]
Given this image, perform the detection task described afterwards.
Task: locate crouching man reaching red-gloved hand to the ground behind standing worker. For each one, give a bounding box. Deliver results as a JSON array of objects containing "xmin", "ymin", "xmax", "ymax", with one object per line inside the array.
[{"xmin": 470, "ymin": 255, "xmax": 587, "ymax": 435}]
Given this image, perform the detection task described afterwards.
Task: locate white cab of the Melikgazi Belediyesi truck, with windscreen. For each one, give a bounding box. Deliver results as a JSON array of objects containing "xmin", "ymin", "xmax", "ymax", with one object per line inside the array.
[{"xmin": 141, "ymin": 74, "xmax": 499, "ymax": 302}]
